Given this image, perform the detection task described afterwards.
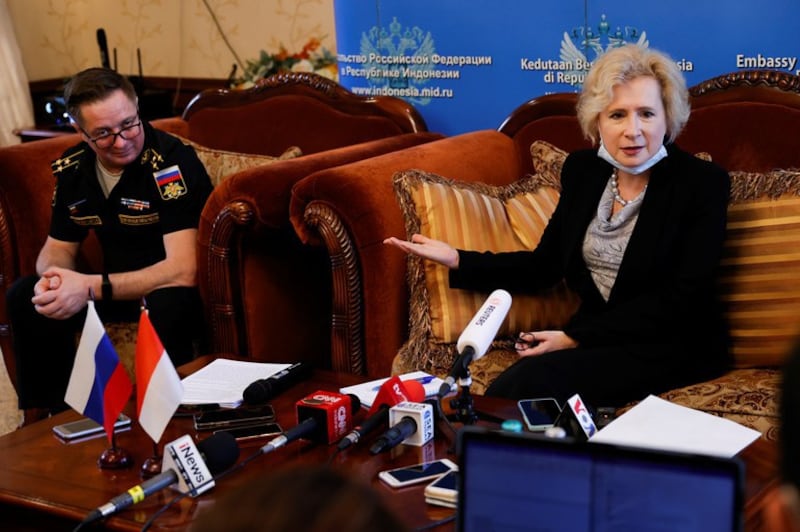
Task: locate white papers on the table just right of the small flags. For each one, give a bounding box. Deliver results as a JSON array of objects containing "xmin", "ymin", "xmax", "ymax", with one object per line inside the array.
[{"xmin": 181, "ymin": 358, "xmax": 291, "ymax": 408}]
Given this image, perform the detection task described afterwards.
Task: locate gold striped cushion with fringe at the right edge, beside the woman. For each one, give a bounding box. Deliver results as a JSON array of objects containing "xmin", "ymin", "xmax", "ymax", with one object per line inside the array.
[{"xmin": 720, "ymin": 169, "xmax": 800, "ymax": 368}]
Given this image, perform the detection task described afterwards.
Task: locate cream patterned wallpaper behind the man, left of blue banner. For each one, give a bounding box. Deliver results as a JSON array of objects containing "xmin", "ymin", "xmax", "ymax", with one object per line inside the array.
[{"xmin": 6, "ymin": 0, "xmax": 336, "ymax": 81}]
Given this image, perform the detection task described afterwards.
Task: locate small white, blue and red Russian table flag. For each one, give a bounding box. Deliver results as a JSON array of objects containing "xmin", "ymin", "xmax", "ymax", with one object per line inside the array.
[{"xmin": 64, "ymin": 300, "xmax": 133, "ymax": 443}]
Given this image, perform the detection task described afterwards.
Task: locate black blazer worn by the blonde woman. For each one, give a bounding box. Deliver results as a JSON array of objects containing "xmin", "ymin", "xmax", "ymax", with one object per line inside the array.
[{"xmin": 450, "ymin": 145, "xmax": 730, "ymax": 357}]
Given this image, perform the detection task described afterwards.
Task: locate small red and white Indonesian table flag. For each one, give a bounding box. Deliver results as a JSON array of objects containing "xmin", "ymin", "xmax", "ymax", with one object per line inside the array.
[{"xmin": 136, "ymin": 309, "xmax": 183, "ymax": 443}]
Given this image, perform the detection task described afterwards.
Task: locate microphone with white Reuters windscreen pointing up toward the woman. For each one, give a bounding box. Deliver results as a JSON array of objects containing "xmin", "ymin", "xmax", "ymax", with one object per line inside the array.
[{"xmin": 439, "ymin": 290, "xmax": 511, "ymax": 398}]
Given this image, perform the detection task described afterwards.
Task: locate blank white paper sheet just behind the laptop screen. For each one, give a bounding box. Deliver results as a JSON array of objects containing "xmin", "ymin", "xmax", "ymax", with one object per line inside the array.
[{"xmin": 590, "ymin": 395, "xmax": 761, "ymax": 458}]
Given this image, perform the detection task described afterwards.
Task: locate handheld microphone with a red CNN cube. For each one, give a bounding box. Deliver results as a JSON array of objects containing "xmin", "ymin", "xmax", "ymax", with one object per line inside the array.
[{"xmin": 259, "ymin": 391, "xmax": 361, "ymax": 454}]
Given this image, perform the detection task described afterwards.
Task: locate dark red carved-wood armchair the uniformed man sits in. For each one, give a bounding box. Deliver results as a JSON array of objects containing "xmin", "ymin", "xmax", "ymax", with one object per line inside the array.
[{"xmin": 0, "ymin": 73, "xmax": 441, "ymax": 390}]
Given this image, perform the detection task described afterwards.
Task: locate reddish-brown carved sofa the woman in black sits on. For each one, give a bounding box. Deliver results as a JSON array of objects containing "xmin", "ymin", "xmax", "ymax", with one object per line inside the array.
[{"xmin": 291, "ymin": 71, "xmax": 800, "ymax": 438}]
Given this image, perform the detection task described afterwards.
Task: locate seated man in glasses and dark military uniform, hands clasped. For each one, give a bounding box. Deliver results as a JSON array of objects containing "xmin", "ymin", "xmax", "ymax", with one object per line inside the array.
[{"xmin": 7, "ymin": 68, "xmax": 212, "ymax": 424}]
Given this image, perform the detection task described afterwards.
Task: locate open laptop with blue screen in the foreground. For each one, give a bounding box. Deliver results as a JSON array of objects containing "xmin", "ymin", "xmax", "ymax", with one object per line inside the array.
[{"xmin": 456, "ymin": 426, "xmax": 744, "ymax": 532}]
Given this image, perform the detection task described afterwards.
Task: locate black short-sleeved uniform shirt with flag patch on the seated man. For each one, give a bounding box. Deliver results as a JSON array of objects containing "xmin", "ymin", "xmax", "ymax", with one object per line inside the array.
[{"xmin": 50, "ymin": 123, "xmax": 212, "ymax": 273}]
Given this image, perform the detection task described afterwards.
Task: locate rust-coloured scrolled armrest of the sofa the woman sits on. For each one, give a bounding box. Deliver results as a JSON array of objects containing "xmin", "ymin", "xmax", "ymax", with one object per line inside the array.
[{"xmin": 290, "ymin": 131, "xmax": 524, "ymax": 377}]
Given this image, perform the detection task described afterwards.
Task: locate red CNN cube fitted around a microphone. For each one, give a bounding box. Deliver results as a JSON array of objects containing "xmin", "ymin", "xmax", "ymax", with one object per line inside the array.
[{"xmin": 295, "ymin": 390, "xmax": 361, "ymax": 444}]
